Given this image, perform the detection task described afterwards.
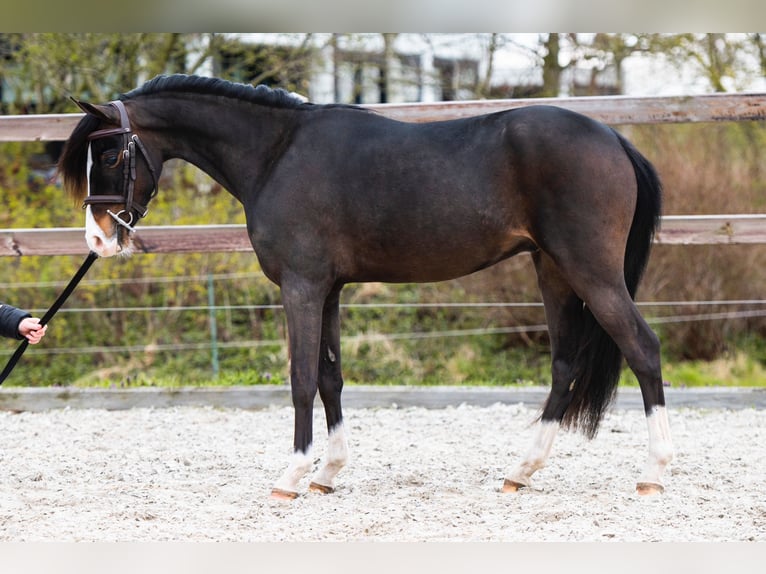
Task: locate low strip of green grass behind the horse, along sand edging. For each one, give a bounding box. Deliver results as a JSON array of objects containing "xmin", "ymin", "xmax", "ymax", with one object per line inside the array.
[{"xmin": 5, "ymin": 335, "xmax": 766, "ymax": 388}]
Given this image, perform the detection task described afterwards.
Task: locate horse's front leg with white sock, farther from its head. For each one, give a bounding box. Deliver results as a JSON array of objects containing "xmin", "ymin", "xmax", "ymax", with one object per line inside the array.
[{"xmin": 309, "ymin": 289, "xmax": 348, "ymax": 494}]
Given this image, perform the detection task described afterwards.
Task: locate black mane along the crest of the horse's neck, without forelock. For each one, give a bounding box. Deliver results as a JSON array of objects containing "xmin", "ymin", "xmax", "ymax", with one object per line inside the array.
[{"xmin": 120, "ymin": 74, "xmax": 314, "ymax": 109}]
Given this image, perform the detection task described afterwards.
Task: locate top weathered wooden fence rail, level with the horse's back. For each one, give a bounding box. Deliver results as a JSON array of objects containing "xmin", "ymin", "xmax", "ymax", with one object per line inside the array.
[{"xmin": 0, "ymin": 94, "xmax": 766, "ymax": 142}]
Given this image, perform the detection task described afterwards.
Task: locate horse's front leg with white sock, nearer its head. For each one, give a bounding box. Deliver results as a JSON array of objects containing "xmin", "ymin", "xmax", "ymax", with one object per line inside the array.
[{"xmin": 271, "ymin": 283, "xmax": 324, "ymax": 499}]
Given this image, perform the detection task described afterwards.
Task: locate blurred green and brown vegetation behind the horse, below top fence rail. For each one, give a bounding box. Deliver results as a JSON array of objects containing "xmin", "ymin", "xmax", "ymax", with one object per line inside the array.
[{"xmin": 0, "ymin": 122, "xmax": 766, "ymax": 392}]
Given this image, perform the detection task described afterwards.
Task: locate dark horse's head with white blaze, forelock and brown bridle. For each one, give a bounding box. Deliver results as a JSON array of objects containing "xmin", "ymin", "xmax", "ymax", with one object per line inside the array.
[{"xmin": 59, "ymin": 100, "xmax": 162, "ymax": 257}]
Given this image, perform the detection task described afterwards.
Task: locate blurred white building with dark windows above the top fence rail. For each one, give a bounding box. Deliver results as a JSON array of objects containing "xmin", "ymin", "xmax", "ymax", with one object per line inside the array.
[{"xmin": 206, "ymin": 33, "xmax": 619, "ymax": 104}]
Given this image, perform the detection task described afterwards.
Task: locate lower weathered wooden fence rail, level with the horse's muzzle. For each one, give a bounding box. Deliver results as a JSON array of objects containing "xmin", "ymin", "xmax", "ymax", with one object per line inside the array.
[{"xmin": 0, "ymin": 214, "xmax": 766, "ymax": 257}]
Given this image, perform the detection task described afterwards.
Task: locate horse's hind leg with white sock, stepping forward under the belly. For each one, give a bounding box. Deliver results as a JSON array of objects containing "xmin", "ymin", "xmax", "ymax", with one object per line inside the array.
[{"xmin": 503, "ymin": 252, "xmax": 583, "ymax": 492}]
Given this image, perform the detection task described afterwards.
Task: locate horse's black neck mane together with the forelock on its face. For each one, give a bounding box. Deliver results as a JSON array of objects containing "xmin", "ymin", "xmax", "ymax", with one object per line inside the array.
[{"xmin": 58, "ymin": 74, "xmax": 362, "ymax": 199}]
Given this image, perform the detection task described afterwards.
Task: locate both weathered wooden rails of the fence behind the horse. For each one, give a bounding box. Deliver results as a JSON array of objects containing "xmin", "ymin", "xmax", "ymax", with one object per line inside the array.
[{"xmin": 0, "ymin": 94, "xmax": 766, "ymax": 257}]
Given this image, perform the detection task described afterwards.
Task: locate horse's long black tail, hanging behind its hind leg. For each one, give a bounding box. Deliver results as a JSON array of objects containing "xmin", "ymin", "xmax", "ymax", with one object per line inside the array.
[{"xmin": 561, "ymin": 132, "xmax": 662, "ymax": 438}]
